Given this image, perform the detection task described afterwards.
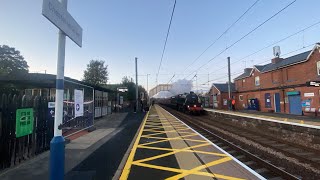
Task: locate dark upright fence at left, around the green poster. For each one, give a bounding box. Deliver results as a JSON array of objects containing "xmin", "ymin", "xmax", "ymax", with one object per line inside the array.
[{"xmin": 0, "ymin": 94, "xmax": 54, "ymax": 171}]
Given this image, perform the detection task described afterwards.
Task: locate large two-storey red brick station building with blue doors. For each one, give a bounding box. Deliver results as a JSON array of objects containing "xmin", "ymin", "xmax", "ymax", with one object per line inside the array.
[{"xmin": 234, "ymin": 44, "xmax": 320, "ymax": 115}]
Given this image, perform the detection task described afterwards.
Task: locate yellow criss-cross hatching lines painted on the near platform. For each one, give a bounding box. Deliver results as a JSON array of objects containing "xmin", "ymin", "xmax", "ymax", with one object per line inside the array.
[{"xmin": 120, "ymin": 105, "xmax": 246, "ymax": 180}]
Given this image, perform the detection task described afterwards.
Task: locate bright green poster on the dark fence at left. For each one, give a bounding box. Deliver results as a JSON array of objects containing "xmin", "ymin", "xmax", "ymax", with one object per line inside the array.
[{"xmin": 16, "ymin": 108, "xmax": 34, "ymax": 137}]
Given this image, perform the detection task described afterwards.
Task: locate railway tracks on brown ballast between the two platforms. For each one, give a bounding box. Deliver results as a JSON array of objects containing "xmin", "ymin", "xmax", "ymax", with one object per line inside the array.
[{"xmin": 164, "ymin": 107, "xmax": 320, "ymax": 180}]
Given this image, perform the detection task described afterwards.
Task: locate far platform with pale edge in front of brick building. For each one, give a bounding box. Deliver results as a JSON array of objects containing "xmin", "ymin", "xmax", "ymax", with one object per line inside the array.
[{"xmin": 205, "ymin": 108, "xmax": 320, "ymax": 129}]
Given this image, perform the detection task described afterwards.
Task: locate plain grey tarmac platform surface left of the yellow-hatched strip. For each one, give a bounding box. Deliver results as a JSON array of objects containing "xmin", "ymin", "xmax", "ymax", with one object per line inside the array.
[{"xmin": 0, "ymin": 113, "xmax": 145, "ymax": 180}]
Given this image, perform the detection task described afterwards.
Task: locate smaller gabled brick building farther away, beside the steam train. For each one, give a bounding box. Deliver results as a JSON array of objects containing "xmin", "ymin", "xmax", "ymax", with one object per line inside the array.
[{"xmin": 209, "ymin": 83, "xmax": 235, "ymax": 110}]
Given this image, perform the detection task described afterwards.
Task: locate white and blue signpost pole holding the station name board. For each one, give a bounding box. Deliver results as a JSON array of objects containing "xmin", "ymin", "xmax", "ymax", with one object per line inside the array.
[{"xmin": 50, "ymin": 0, "xmax": 67, "ymax": 180}]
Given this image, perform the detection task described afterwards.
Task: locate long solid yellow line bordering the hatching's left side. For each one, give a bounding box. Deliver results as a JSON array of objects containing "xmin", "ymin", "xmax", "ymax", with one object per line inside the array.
[{"xmin": 120, "ymin": 111, "xmax": 150, "ymax": 180}]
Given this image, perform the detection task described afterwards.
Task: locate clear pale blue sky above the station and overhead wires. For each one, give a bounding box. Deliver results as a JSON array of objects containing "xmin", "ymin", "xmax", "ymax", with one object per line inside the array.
[{"xmin": 0, "ymin": 0, "xmax": 320, "ymax": 93}]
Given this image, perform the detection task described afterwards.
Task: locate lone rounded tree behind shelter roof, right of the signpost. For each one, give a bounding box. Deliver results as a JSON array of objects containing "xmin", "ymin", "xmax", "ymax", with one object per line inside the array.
[{"xmin": 83, "ymin": 60, "xmax": 109, "ymax": 85}]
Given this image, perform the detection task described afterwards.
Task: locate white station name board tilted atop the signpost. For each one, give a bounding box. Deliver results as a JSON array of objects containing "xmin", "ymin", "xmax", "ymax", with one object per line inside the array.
[{"xmin": 42, "ymin": 0, "xmax": 82, "ymax": 47}]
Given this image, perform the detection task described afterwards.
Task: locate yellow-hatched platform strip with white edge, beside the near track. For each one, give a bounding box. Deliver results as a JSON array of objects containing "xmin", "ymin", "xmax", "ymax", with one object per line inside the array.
[{"xmin": 119, "ymin": 105, "xmax": 264, "ymax": 180}]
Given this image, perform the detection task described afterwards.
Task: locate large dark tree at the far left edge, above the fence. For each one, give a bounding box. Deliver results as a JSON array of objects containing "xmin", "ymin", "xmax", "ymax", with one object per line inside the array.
[{"xmin": 0, "ymin": 45, "xmax": 29, "ymax": 75}]
